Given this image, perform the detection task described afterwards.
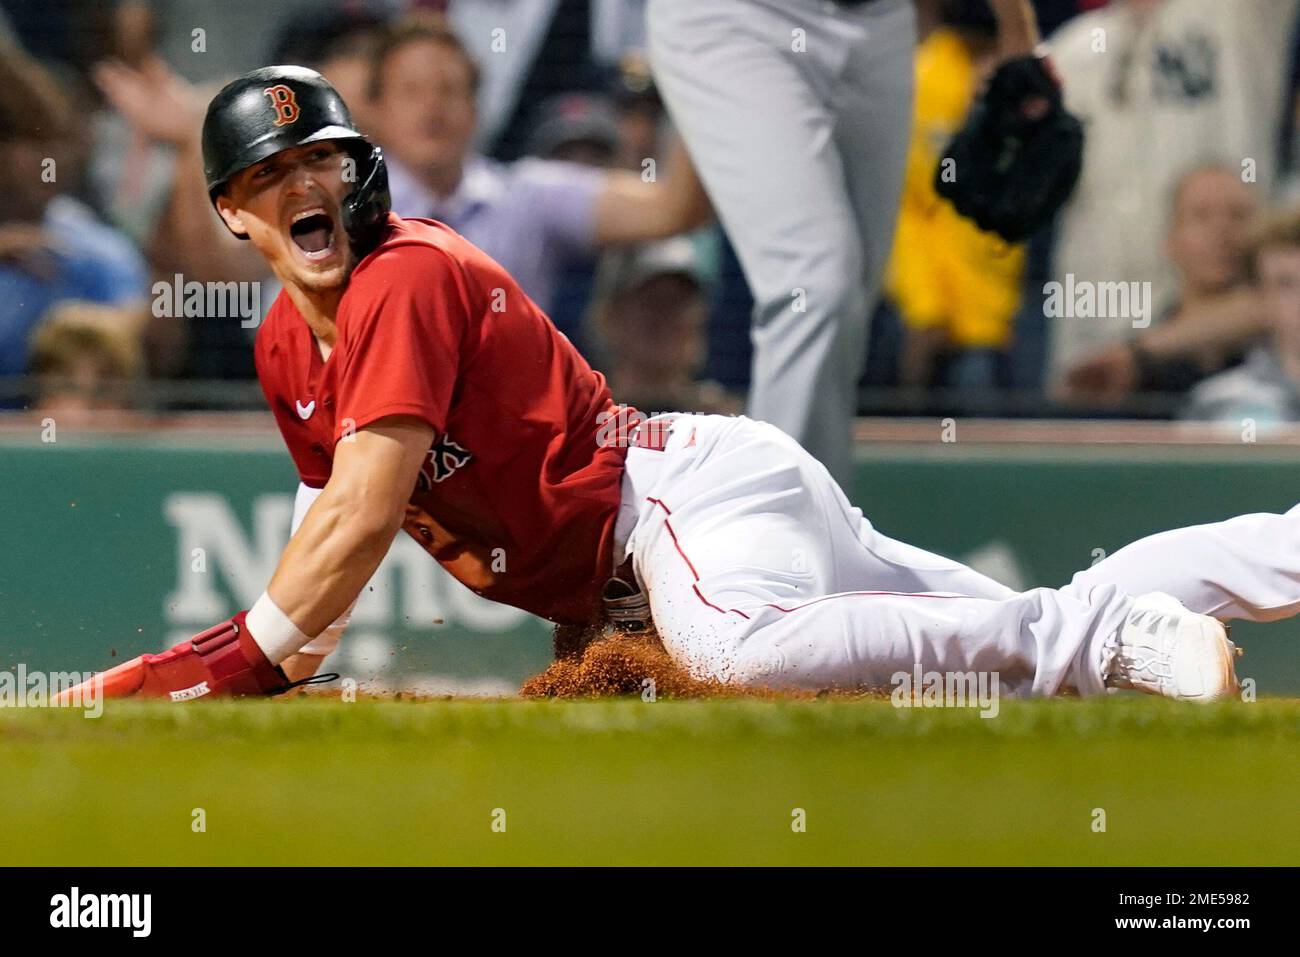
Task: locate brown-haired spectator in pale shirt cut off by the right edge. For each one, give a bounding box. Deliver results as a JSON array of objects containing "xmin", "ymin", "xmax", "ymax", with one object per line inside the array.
[{"xmin": 1183, "ymin": 209, "xmax": 1300, "ymax": 428}]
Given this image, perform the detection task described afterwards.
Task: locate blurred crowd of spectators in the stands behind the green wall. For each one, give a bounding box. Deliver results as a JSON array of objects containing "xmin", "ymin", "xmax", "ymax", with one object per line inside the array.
[{"xmin": 0, "ymin": 0, "xmax": 1300, "ymax": 426}]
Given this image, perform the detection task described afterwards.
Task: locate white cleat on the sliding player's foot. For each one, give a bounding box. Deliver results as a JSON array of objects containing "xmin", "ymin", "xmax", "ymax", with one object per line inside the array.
[{"xmin": 1101, "ymin": 592, "xmax": 1240, "ymax": 701}]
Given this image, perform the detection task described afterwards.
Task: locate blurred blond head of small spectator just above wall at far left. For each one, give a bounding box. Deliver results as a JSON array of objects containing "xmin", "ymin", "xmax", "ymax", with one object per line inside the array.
[{"xmin": 27, "ymin": 300, "xmax": 146, "ymax": 424}]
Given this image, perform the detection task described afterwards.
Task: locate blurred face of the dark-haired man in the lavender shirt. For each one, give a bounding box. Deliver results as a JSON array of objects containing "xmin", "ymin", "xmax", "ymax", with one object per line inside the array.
[{"xmin": 374, "ymin": 40, "xmax": 476, "ymax": 173}]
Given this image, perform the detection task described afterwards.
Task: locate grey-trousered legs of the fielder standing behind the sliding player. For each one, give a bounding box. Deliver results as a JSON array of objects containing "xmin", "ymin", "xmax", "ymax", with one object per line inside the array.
[{"xmin": 647, "ymin": 0, "xmax": 911, "ymax": 480}]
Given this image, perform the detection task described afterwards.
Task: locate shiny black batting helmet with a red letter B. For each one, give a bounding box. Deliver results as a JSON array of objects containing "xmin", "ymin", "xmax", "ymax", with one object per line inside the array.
[{"xmin": 203, "ymin": 66, "xmax": 391, "ymax": 255}]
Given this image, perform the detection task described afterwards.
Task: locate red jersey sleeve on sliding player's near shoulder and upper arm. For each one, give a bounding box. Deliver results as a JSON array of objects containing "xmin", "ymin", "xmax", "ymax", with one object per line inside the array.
[{"xmin": 334, "ymin": 246, "xmax": 469, "ymax": 439}]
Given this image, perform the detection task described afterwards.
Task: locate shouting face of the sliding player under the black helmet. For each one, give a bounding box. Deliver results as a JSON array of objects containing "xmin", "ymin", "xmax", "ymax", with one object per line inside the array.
[{"xmin": 217, "ymin": 142, "xmax": 355, "ymax": 291}]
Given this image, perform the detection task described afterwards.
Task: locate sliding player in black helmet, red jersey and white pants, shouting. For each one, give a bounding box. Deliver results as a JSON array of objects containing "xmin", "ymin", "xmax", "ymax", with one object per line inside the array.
[{"xmin": 58, "ymin": 66, "xmax": 1300, "ymax": 701}]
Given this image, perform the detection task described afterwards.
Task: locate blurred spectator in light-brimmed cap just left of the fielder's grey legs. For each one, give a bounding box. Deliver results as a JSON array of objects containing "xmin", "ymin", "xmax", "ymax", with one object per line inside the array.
[{"xmin": 592, "ymin": 237, "xmax": 744, "ymax": 415}]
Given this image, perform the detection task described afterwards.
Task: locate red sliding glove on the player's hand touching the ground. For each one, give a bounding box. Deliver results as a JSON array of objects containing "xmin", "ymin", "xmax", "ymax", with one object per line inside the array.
[{"xmin": 60, "ymin": 611, "xmax": 291, "ymax": 701}]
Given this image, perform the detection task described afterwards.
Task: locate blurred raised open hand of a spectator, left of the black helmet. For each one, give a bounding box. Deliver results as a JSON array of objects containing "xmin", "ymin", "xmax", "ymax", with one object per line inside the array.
[{"xmin": 94, "ymin": 56, "xmax": 204, "ymax": 148}]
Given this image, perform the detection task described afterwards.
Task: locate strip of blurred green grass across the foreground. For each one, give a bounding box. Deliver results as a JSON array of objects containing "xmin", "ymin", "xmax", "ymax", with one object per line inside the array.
[{"xmin": 0, "ymin": 698, "xmax": 1300, "ymax": 865}]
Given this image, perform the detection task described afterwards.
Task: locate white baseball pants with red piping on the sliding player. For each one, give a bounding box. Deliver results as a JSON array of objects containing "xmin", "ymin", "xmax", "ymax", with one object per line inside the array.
[{"xmin": 615, "ymin": 415, "xmax": 1300, "ymax": 696}]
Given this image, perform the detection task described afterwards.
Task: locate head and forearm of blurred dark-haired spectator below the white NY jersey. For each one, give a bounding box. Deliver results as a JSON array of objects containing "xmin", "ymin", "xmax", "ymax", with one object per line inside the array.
[{"xmin": 1065, "ymin": 164, "xmax": 1261, "ymax": 402}]
